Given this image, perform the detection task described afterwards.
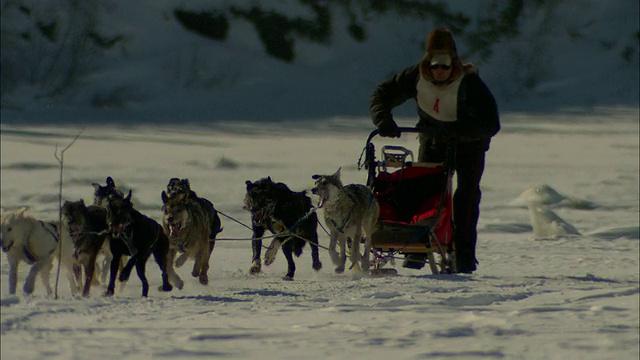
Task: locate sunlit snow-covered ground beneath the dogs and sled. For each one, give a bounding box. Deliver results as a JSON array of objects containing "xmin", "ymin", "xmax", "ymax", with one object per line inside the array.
[{"xmin": 0, "ymin": 108, "xmax": 640, "ymax": 360}]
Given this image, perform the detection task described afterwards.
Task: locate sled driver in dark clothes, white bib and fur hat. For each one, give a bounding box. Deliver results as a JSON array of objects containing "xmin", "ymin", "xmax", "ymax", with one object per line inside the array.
[{"xmin": 370, "ymin": 28, "xmax": 500, "ymax": 274}]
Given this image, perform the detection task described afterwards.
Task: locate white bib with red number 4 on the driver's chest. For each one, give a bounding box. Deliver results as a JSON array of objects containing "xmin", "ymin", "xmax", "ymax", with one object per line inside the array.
[{"xmin": 416, "ymin": 76, "xmax": 463, "ymax": 122}]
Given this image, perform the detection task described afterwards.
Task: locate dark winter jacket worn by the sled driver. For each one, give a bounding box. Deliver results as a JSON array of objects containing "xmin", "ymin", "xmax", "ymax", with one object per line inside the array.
[{"xmin": 370, "ymin": 65, "xmax": 500, "ymax": 149}]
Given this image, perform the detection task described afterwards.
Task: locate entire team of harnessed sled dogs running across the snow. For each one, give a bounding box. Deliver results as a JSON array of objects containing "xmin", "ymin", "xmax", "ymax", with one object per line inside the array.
[{"xmin": 0, "ymin": 169, "xmax": 380, "ymax": 297}]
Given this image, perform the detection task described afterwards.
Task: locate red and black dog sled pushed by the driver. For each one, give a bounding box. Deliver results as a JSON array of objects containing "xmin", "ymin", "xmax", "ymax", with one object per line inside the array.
[{"xmin": 360, "ymin": 127, "xmax": 454, "ymax": 275}]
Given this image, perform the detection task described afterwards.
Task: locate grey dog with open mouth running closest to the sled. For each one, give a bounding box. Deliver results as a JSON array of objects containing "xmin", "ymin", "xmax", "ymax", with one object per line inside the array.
[{"xmin": 312, "ymin": 169, "xmax": 380, "ymax": 274}]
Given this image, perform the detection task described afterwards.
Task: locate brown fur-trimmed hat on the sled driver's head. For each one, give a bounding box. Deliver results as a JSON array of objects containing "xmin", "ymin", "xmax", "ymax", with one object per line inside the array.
[{"xmin": 420, "ymin": 28, "xmax": 462, "ymax": 81}]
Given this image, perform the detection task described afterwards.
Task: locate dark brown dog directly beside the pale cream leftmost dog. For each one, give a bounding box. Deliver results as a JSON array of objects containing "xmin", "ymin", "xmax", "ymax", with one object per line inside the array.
[{"xmin": 62, "ymin": 199, "xmax": 112, "ymax": 296}]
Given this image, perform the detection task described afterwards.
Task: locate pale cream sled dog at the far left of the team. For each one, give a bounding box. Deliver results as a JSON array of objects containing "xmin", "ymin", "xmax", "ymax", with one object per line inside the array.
[{"xmin": 0, "ymin": 208, "xmax": 80, "ymax": 295}]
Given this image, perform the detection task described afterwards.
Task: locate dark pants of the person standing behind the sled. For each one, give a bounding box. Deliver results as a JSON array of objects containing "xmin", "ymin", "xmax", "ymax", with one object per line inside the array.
[{"xmin": 418, "ymin": 138, "xmax": 489, "ymax": 272}]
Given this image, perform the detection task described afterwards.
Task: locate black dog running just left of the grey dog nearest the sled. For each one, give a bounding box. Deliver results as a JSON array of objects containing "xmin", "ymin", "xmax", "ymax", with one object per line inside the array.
[{"xmin": 243, "ymin": 177, "xmax": 322, "ymax": 280}]
